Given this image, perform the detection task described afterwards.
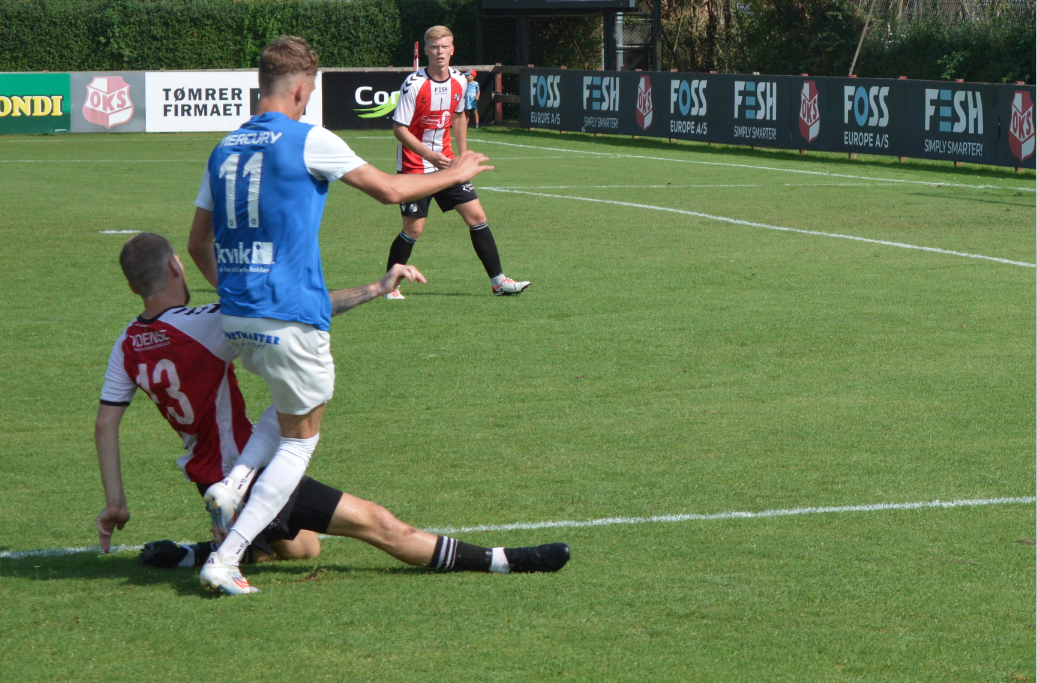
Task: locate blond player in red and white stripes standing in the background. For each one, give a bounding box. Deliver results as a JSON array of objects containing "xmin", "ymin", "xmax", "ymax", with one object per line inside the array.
[{"xmin": 386, "ymin": 26, "xmax": 529, "ymax": 300}]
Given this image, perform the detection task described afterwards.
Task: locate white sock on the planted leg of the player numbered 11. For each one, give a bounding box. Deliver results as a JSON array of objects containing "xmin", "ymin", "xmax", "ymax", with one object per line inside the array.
[{"xmin": 219, "ymin": 434, "xmax": 320, "ymax": 565}]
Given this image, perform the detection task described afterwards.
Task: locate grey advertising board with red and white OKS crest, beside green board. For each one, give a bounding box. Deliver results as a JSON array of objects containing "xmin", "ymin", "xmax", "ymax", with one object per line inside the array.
[{"xmin": 69, "ymin": 72, "xmax": 146, "ymax": 133}]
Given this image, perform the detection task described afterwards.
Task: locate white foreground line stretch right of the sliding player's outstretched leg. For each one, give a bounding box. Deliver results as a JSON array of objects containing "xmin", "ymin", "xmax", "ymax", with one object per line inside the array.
[{"xmin": 427, "ymin": 495, "xmax": 1037, "ymax": 534}]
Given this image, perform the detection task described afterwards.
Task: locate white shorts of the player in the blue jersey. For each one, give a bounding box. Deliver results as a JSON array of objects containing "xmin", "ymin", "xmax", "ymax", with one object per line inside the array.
[{"xmin": 223, "ymin": 315, "xmax": 335, "ymax": 415}]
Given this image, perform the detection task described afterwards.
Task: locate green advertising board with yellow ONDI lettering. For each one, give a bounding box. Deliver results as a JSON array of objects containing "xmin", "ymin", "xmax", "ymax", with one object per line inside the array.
[{"xmin": 0, "ymin": 74, "xmax": 72, "ymax": 135}]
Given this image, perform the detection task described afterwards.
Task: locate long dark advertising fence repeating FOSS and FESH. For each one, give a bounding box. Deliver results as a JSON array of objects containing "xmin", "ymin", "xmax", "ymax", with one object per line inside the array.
[{"xmin": 520, "ymin": 68, "xmax": 1035, "ymax": 168}]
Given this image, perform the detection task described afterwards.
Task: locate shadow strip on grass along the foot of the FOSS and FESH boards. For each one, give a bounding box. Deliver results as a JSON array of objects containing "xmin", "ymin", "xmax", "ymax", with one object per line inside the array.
[{"xmin": 473, "ymin": 129, "xmax": 1034, "ymax": 183}]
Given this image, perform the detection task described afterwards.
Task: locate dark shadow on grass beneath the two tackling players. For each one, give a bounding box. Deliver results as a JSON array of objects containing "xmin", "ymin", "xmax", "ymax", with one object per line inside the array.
[{"xmin": 0, "ymin": 552, "xmax": 440, "ymax": 598}]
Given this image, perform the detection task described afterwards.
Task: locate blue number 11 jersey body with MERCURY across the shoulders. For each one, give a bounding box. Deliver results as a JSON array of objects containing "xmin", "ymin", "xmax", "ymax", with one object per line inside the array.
[{"xmin": 208, "ymin": 113, "xmax": 331, "ymax": 332}]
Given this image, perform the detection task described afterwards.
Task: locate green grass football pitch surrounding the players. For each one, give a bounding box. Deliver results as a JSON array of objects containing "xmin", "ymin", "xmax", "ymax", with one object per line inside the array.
[{"xmin": 0, "ymin": 131, "xmax": 1037, "ymax": 683}]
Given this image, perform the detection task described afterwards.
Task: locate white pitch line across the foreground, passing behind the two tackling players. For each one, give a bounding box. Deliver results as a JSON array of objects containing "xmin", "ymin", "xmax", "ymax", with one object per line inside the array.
[{"xmin": 0, "ymin": 495, "xmax": 1037, "ymax": 560}]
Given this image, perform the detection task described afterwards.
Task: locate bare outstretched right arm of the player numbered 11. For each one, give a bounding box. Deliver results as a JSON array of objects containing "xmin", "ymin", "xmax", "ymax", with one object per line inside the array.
[{"xmin": 340, "ymin": 150, "xmax": 494, "ymax": 208}]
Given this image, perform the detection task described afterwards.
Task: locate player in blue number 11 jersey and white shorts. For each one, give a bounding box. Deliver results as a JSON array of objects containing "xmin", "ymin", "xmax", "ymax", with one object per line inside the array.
[{"xmin": 188, "ymin": 36, "xmax": 493, "ymax": 595}]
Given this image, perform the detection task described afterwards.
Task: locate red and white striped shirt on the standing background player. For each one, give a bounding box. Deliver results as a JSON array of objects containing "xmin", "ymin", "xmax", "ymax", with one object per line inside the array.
[{"xmin": 392, "ymin": 68, "xmax": 468, "ymax": 173}]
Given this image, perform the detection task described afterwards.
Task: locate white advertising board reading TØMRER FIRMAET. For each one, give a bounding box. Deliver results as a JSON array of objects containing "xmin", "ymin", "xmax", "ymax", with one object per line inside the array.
[{"xmin": 144, "ymin": 70, "xmax": 324, "ymax": 133}]
